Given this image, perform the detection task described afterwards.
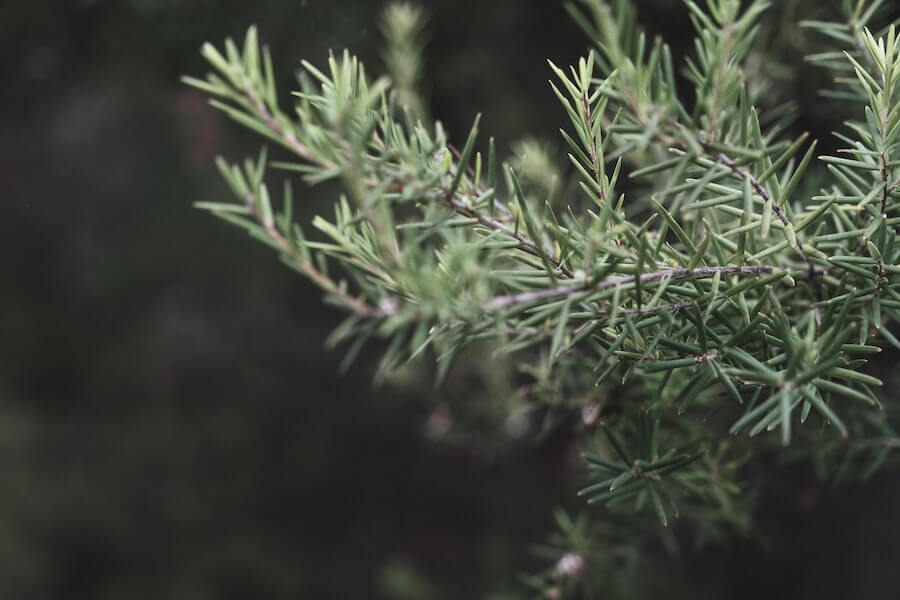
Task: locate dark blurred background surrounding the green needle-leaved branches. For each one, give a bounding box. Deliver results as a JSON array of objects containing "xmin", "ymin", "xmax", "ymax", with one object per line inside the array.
[{"xmin": 0, "ymin": 0, "xmax": 900, "ymax": 600}]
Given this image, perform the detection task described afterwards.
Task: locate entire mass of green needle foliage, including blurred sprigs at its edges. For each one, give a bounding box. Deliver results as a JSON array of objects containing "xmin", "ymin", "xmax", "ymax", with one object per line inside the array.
[{"xmin": 185, "ymin": 0, "xmax": 900, "ymax": 597}]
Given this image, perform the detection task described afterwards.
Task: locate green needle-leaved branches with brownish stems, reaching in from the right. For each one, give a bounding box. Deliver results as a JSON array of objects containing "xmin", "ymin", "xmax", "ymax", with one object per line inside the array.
[{"xmin": 185, "ymin": 5, "xmax": 900, "ymax": 585}]
